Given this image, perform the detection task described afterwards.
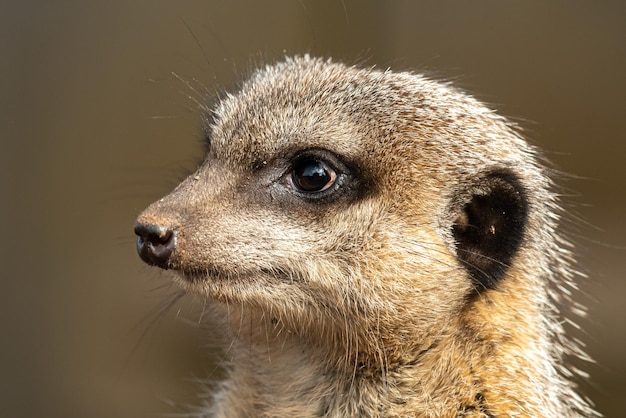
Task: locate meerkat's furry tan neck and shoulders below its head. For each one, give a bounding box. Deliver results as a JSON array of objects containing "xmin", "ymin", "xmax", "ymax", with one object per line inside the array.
[{"xmin": 206, "ymin": 290, "xmax": 568, "ymax": 417}]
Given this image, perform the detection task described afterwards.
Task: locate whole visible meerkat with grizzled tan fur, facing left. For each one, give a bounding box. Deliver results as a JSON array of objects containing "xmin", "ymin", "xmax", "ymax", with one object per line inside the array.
[{"xmin": 135, "ymin": 56, "xmax": 596, "ymax": 417}]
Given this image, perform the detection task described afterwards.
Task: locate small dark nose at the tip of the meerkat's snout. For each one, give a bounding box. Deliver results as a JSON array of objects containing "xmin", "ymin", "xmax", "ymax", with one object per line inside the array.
[{"xmin": 135, "ymin": 222, "xmax": 177, "ymax": 269}]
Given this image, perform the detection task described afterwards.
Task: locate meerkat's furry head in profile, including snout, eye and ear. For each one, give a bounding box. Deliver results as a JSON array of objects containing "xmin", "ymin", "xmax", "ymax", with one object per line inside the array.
[{"xmin": 135, "ymin": 56, "xmax": 554, "ymax": 352}]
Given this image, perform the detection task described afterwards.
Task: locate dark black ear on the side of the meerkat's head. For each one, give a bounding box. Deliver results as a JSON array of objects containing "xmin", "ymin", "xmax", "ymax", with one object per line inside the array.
[{"xmin": 452, "ymin": 171, "xmax": 528, "ymax": 291}]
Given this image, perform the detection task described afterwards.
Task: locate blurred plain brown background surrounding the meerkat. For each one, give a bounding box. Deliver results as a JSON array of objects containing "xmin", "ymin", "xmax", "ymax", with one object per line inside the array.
[{"xmin": 0, "ymin": 0, "xmax": 626, "ymax": 418}]
